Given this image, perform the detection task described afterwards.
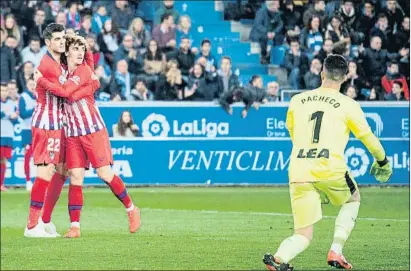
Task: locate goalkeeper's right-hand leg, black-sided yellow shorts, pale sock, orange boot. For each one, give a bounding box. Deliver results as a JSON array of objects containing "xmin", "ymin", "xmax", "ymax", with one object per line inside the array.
[{"xmin": 323, "ymin": 173, "xmax": 361, "ymax": 269}]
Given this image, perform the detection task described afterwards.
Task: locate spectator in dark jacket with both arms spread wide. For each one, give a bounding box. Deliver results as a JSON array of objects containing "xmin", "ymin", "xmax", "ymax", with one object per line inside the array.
[{"xmin": 359, "ymin": 36, "xmax": 409, "ymax": 85}]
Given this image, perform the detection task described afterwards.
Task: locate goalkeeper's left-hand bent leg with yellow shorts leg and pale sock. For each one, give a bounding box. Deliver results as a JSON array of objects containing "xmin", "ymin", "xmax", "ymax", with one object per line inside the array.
[{"xmin": 263, "ymin": 183, "xmax": 322, "ymax": 271}]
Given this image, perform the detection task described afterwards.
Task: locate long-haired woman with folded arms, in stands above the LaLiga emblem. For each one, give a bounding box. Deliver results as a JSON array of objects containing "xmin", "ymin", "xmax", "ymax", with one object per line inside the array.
[{"xmin": 143, "ymin": 40, "xmax": 166, "ymax": 90}]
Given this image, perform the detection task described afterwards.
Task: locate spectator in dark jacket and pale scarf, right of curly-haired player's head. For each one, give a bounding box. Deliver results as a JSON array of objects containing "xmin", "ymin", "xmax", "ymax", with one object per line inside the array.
[{"xmin": 97, "ymin": 20, "xmax": 121, "ymax": 66}]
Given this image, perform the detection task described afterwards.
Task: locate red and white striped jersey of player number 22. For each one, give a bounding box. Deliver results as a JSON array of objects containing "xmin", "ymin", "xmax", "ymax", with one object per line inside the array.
[{"xmin": 32, "ymin": 52, "xmax": 67, "ymax": 130}]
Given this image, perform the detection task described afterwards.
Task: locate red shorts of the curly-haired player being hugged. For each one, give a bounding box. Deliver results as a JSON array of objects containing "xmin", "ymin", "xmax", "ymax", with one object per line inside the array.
[{"xmin": 66, "ymin": 129, "xmax": 113, "ymax": 169}]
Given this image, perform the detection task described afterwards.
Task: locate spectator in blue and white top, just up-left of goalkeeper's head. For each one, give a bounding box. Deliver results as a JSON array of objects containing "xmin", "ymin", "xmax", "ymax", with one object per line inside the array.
[{"xmin": 300, "ymin": 16, "xmax": 323, "ymax": 55}]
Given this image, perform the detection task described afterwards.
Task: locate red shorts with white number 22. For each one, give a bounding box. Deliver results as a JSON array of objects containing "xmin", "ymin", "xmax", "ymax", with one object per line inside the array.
[{"xmin": 31, "ymin": 127, "xmax": 65, "ymax": 165}]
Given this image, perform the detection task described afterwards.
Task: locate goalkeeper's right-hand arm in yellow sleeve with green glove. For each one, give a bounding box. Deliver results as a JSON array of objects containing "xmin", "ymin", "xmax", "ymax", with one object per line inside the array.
[{"xmin": 347, "ymin": 102, "xmax": 392, "ymax": 182}]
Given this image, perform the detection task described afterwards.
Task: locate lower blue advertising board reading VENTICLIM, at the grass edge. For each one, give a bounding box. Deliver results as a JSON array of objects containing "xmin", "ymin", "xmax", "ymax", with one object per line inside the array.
[{"xmin": 6, "ymin": 139, "xmax": 410, "ymax": 185}]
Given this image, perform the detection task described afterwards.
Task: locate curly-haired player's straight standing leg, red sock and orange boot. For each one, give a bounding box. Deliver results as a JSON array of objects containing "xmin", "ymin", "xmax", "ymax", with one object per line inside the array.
[{"xmin": 64, "ymin": 168, "xmax": 86, "ymax": 238}]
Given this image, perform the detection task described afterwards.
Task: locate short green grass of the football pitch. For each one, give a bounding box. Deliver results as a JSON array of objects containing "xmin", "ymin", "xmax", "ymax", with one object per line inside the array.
[{"xmin": 1, "ymin": 187, "xmax": 410, "ymax": 270}]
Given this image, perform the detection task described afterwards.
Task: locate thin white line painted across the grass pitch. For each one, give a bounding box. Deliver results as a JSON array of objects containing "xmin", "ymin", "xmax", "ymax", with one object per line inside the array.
[{"xmin": 142, "ymin": 208, "xmax": 409, "ymax": 222}]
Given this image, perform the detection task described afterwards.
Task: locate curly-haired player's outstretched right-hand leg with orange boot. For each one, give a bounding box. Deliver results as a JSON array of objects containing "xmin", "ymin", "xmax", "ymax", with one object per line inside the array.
[{"xmin": 84, "ymin": 130, "xmax": 141, "ymax": 233}]
